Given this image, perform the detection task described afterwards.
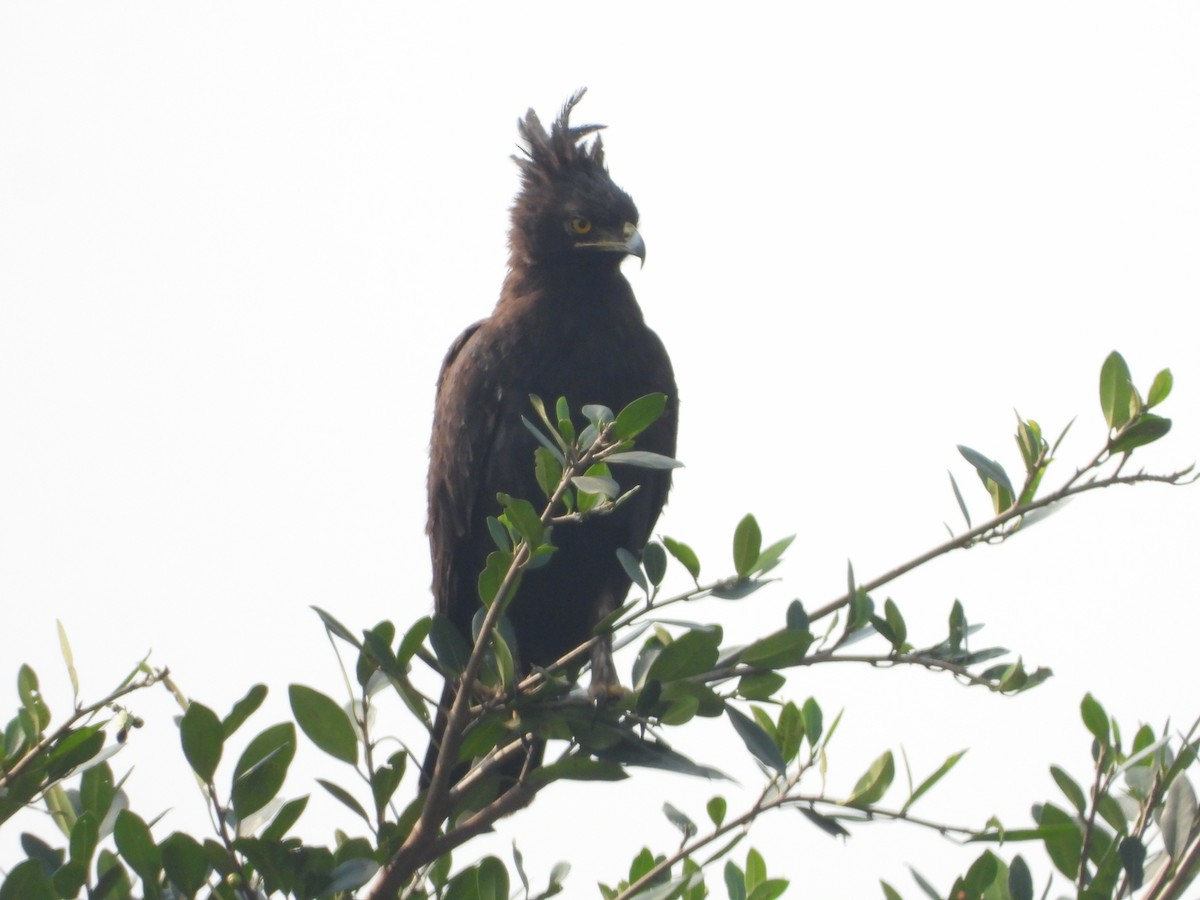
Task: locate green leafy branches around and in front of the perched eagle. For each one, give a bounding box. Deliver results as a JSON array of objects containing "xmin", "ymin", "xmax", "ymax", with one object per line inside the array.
[{"xmin": 0, "ymin": 353, "xmax": 1200, "ymax": 900}]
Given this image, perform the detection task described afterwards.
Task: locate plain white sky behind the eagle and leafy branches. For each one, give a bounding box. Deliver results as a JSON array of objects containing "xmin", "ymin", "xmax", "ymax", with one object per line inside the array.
[{"xmin": 0, "ymin": 2, "xmax": 1200, "ymax": 896}]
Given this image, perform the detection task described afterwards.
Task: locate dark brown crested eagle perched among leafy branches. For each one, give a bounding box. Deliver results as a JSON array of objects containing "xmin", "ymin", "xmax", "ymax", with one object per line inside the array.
[{"xmin": 424, "ymin": 90, "xmax": 678, "ymax": 781}]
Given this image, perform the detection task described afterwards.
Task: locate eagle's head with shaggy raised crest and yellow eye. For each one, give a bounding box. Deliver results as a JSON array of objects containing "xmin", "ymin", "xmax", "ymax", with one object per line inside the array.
[{"xmin": 509, "ymin": 89, "xmax": 646, "ymax": 274}]
